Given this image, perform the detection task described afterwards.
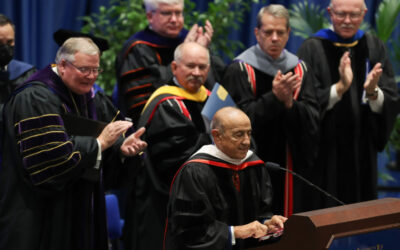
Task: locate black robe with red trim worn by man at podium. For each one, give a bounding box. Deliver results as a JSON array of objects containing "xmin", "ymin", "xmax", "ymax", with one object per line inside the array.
[{"xmin": 165, "ymin": 150, "xmax": 272, "ymax": 250}]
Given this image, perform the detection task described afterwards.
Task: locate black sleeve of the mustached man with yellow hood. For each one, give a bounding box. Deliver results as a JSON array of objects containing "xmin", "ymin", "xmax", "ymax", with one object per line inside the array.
[{"xmin": 141, "ymin": 99, "xmax": 211, "ymax": 194}]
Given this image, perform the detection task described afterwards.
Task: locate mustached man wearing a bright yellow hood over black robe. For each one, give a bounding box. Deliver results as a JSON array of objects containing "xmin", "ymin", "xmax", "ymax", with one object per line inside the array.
[{"xmin": 125, "ymin": 42, "xmax": 211, "ymax": 250}]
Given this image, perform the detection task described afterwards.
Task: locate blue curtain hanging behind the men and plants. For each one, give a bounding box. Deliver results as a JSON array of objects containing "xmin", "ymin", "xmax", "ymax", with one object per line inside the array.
[{"xmin": 0, "ymin": 0, "xmax": 399, "ymax": 69}]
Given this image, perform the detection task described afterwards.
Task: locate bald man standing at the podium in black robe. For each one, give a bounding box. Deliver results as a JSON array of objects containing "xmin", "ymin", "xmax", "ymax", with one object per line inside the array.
[{"xmin": 164, "ymin": 107, "xmax": 287, "ymax": 250}]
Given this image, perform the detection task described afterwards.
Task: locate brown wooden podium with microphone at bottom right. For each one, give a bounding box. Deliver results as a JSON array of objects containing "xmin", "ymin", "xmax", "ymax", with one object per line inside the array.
[{"xmin": 248, "ymin": 198, "xmax": 400, "ymax": 250}]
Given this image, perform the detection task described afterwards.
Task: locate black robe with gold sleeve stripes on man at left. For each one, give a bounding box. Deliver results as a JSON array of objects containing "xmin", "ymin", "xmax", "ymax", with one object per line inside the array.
[{"xmin": 0, "ymin": 67, "xmax": 135, "ymax": 250}]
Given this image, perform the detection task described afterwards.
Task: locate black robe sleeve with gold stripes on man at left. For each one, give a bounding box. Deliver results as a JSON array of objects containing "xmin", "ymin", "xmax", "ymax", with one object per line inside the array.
[{"xmin": 10, "ymin": 86, "xmax": 98, "ymax": 190}]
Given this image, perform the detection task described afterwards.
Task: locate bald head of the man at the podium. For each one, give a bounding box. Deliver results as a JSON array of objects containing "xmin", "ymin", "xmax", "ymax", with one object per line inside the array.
[{"xmin": 211, "ymin": 107, "xmax": 251, "ymax": 159}]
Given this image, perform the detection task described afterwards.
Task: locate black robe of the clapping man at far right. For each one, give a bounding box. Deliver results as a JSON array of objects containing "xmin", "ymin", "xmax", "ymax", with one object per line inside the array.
[{"xmin": 298, "ymin": 34, "xmax": 397, "ymax": 209}]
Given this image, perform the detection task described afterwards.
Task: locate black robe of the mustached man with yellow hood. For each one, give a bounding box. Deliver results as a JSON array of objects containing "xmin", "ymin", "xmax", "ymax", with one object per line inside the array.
[{"xmin": 124, "ymin": 86, "xmax": 211, "ymax": 250}]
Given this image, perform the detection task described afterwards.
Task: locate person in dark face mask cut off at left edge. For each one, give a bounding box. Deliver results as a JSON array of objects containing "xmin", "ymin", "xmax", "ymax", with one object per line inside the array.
[{"xmin": 0, "ymin": 14, "xmax": 36, "ymax": 107}]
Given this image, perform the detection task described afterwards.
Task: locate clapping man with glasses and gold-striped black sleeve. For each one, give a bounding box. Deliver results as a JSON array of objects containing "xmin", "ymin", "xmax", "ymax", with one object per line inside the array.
[{"xmin": 0, "ymin": 38, "xmax": 147, "ymax": 250}]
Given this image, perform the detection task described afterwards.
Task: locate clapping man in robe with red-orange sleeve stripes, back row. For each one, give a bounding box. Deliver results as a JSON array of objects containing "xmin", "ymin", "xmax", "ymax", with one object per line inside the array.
[{"xmin": 116, "ymin": 0, "xmax": 225, "ymax": 124}]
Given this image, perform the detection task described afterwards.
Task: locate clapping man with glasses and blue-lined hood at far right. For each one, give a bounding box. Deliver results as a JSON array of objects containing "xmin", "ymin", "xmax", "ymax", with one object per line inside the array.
[{"xmin": 298, "ymin": 0, "xmax": 398, "ymax": 211}]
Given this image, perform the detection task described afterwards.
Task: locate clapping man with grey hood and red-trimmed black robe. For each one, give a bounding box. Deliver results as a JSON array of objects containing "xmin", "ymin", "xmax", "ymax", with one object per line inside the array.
[{"xmin": 222, "ymin": 4, "xmax": 319, "ymax": 216}]
